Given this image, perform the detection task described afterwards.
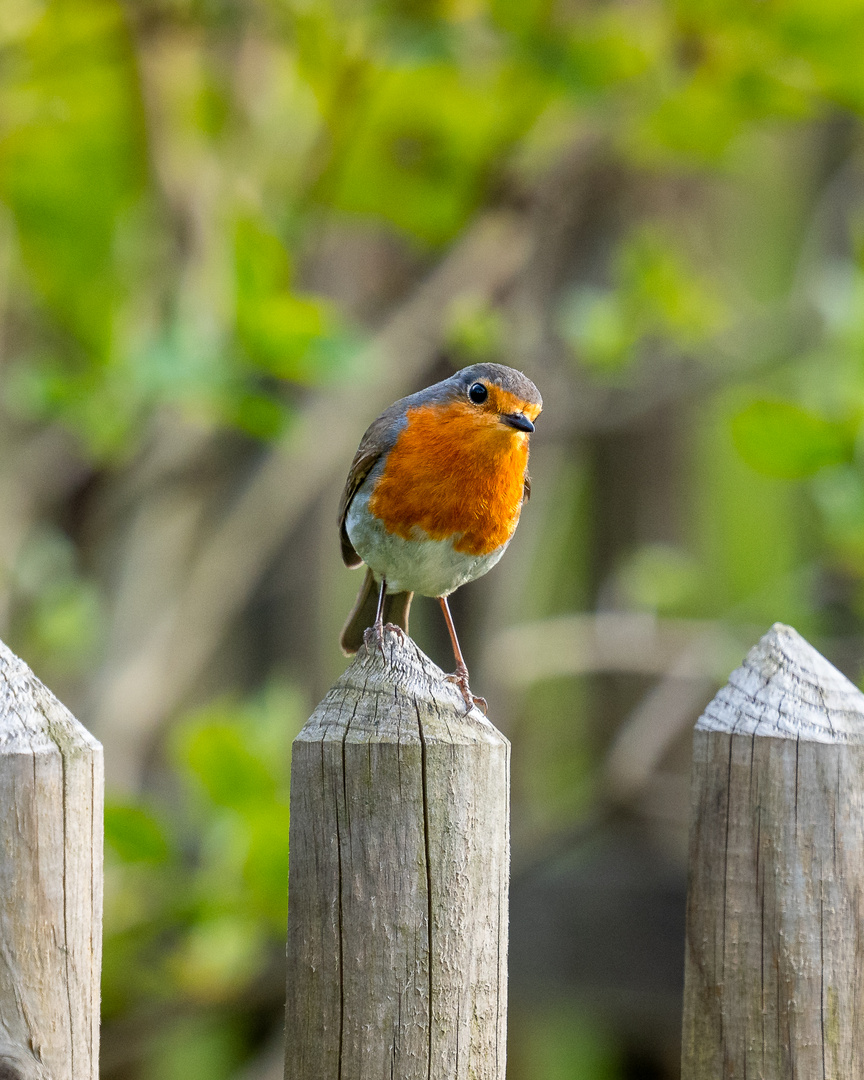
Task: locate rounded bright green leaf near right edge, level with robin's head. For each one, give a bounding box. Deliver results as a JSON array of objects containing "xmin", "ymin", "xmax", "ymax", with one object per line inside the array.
[{"xmin": 731, "ymin": 401, "xmax": 854, "ymax": 480}]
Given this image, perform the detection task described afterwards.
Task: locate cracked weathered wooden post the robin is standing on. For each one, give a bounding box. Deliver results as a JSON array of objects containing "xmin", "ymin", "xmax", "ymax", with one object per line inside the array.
[{"xmin": 285, "ymin": 631, "xmax": 510, "ymax": 1080}]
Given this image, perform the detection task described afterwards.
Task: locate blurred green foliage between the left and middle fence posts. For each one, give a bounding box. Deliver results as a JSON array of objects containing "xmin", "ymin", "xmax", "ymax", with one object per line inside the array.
[{"xmin": 103, "ymin": 686, "xmax": 306, "ymax": 1077}]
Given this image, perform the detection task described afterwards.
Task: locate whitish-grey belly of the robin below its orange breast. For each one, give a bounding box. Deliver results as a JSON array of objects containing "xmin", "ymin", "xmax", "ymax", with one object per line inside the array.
[{"xmin": 346, "ymin": 484, "xmax": 510, "ymax": 596}]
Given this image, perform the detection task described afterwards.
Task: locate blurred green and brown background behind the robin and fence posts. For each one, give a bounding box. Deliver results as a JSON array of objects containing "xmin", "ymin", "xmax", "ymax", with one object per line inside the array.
[{"xmin": 0, "ymin": 0, "xmax": 864, "ymax": 1080}]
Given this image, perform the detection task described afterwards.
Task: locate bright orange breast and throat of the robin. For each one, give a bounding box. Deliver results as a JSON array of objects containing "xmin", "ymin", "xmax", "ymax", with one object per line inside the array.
[{"xmin": 369, "ymin": 402, "xmax": 528, "ymax": 555}]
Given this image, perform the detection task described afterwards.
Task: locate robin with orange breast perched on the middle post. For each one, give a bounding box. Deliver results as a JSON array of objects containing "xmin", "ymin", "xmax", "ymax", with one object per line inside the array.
[{"xmin": 339, "ymin": 364, "xmax": 543, "ymax": 708}]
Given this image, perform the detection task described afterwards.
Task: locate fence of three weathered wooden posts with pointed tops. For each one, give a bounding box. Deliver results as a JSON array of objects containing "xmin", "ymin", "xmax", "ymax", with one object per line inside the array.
[{"xmin": 0, "ymin": 625, "xmax": 864, "ymax": 1080}]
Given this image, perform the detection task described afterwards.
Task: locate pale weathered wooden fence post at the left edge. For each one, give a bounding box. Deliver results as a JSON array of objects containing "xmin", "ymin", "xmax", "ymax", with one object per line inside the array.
[{"xmin": 0, "ymin": 642, "xmax": 103, "ymax": 1080}]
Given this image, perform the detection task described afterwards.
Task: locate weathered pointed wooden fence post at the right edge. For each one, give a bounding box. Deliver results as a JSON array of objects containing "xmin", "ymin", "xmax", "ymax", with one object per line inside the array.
[{"xmin": 683, "ymin": 624, "xmax": 864, "ymax": 1080}]
